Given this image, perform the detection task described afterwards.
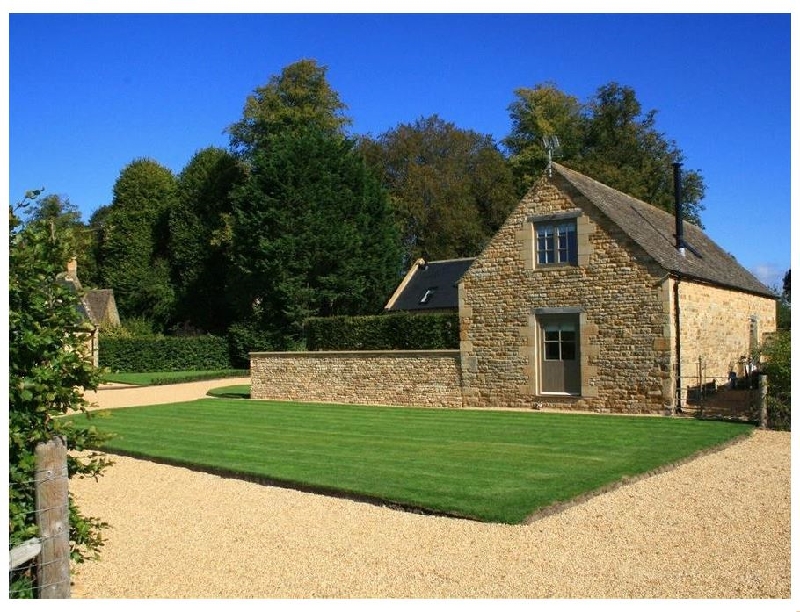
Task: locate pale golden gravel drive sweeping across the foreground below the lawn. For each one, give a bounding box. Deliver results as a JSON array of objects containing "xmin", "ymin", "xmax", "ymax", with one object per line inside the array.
[{"xmin": 70, "ymin": 382, "xmax": 791, "ymax": 599}]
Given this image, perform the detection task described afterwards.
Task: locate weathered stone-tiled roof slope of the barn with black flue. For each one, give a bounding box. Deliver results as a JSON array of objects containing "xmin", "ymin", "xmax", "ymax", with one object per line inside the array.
[{"xmin": 553, "ymin": 163, "xmax": 776, "ymax": 297}]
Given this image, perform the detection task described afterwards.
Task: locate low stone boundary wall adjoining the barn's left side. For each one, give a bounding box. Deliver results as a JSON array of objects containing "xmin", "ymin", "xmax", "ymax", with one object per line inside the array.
[{"xmin": 250, "ymin": 350, "xmax": 462, "ymax": 408}]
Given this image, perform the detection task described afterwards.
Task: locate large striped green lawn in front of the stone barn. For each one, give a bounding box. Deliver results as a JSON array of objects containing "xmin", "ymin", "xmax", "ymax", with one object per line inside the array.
[{"xmin": 78, "ymin": 398, "xmax": 752, "ymax": 523}]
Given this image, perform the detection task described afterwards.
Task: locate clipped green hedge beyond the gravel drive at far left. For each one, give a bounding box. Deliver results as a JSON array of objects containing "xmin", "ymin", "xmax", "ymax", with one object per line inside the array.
[{"xmin": 99, "ymin": 334, "xmax": 231, "ymax": 372}]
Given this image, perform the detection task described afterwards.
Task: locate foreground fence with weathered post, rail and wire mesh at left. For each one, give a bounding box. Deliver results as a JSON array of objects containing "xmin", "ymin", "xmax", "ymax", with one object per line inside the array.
[{"xmin": 8, "ymin": 438, "xmax": 70, "ymax": 599}]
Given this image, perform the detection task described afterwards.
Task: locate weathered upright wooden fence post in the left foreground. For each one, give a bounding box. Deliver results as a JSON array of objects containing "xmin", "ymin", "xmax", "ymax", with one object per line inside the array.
[{"xmin": 35, "ymin": 438, "xmax": 69, "ymax": 599}]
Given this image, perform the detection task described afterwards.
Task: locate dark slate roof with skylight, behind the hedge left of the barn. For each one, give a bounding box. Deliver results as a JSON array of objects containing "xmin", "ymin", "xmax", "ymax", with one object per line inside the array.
[{"xmin": 386, "ymin": 257, "xmax": 475, "ymax": 312}]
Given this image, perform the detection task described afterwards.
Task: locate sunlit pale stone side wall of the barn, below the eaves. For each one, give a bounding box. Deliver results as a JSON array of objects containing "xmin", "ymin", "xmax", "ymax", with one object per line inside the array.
[{"xmin": 678, "ymin": 279, "xmax": 777, "ymax": 387}]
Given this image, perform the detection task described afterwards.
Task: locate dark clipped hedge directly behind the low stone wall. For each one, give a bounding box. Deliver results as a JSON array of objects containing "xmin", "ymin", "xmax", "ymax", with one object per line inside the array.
[{"xmin": 305, "ymin": 313, "xmax": 459, "ymax": 351}]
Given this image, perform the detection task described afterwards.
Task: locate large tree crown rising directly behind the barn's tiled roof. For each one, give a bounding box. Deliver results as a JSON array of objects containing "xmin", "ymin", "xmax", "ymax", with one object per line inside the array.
[{"xmin": 503, "ymin": 82, "xmax": 705, "ymax": 225}]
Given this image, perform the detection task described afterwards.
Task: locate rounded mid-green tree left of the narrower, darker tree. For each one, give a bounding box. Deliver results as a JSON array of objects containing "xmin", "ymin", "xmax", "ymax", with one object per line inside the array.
[{"xmin": 98, "ymin": 158, "xmax": 177, "ymax": 329}]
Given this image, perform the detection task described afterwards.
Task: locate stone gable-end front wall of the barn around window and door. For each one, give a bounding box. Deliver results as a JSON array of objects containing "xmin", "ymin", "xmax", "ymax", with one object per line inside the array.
[{"xmin": 460, "ymin": 177, "xmax": 673, "ymax": 413}]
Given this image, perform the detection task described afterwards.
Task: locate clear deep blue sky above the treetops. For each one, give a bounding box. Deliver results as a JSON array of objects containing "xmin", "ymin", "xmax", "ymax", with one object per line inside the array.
[{"xmin": 8, "ymin": 7, "xmax": 791, "ymax": 286}]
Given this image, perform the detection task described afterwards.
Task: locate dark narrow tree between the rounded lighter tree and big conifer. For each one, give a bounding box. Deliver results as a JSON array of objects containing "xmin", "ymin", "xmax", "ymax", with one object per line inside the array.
[{"xmin": 169, "ymin": 147, "xmax": 245, "ymax": 333}]
